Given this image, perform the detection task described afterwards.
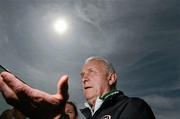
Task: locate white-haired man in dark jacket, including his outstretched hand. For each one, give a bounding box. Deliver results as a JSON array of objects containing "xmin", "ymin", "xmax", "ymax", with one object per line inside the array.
[{"xmin": 0, "ymin": 57, "xmax": 155, "ymax": 119}]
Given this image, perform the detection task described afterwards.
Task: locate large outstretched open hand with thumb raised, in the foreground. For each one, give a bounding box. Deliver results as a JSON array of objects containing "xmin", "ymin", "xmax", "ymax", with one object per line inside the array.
[{"xmin": 0, "ymin": 72, "xmax": 69, "ymax": 119}]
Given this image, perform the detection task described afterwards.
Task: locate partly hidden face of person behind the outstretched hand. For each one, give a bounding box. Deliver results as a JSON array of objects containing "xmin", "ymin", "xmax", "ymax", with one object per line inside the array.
[{"xmin": 65, "ymin": 103, "xmax": 76, "ymax": 119}]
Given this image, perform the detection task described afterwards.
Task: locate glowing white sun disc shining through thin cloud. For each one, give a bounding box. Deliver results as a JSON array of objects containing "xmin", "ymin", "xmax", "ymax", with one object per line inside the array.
[{"xmin": 54, "ymin": 18, "xmax": 68, "ymax": 34}]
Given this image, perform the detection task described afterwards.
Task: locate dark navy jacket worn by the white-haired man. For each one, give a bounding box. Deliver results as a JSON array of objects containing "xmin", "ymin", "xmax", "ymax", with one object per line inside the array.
[{"xmin": 80, "ymin": 91, "xmax": 155, "ymax": 119}]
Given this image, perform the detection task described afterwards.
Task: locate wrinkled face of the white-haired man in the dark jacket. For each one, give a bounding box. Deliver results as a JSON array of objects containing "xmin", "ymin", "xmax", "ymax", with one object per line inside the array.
[{"xmin": 81, "ymin": 60, "xmax": 110, "ymax": 105}]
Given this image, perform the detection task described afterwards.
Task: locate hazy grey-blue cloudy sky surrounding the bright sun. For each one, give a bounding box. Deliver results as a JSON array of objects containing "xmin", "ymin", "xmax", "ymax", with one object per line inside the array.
[{"xmin": 0, "ymin": 0, "xmax": 180, "ymax": 119}]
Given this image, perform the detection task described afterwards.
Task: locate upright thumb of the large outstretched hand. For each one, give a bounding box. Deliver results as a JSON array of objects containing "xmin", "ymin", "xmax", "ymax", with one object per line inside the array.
[{"xmin": 57, "ymin": 75, "xmax": 69, "ymax": 100}]
